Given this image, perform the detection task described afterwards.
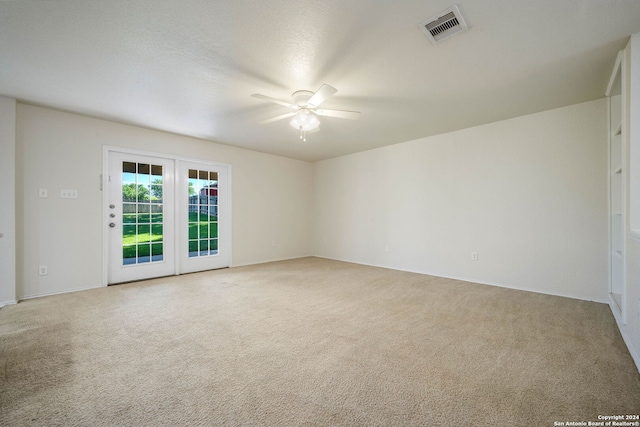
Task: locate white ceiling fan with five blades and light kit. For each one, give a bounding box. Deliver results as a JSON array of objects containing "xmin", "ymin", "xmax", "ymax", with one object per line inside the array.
[{"xmin": 251, "ymin": 84, "xmax": 360, "ymax": 141}]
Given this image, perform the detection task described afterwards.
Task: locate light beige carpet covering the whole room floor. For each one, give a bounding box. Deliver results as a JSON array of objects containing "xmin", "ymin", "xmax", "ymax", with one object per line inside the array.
[{"xmin": 0, "ymin": 258, "xmax": 640, "ymax": 426}]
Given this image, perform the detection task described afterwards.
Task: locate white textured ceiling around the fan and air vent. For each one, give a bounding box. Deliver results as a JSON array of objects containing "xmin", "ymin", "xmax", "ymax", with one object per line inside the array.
[{"xmin": 0, "ymin": 0, "xmax": 640, "ymax": 161}]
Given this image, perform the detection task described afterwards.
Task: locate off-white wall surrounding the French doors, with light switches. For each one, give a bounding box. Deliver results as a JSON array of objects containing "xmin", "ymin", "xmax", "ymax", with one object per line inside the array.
[{"xmin": 16, "ymin": 104, "xmax": 313, "ymax": 298}]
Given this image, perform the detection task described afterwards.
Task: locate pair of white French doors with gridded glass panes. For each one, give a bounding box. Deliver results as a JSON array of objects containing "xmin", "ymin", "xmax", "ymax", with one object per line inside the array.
[{"xmin": 105, "ymin": 150, "xmax": 230, "ymax": 284}]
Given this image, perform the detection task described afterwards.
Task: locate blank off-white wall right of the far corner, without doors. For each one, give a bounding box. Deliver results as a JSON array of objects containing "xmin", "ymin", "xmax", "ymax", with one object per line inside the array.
[{"xmin": 314, "ymin": 99, "xmax": 608, "ymax": 302}]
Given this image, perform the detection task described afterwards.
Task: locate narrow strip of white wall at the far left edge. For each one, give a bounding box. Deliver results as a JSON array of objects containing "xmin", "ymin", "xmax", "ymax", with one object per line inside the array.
[{"xmin": 0, "ymin": 96, "xmax": 16, "ymax": 307}]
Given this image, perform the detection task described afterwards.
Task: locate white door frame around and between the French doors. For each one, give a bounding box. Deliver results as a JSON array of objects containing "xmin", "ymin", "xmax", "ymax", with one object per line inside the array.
[{"xmin": 101, "ymin": 145, "xmax": 233, "ymax": 286}]
